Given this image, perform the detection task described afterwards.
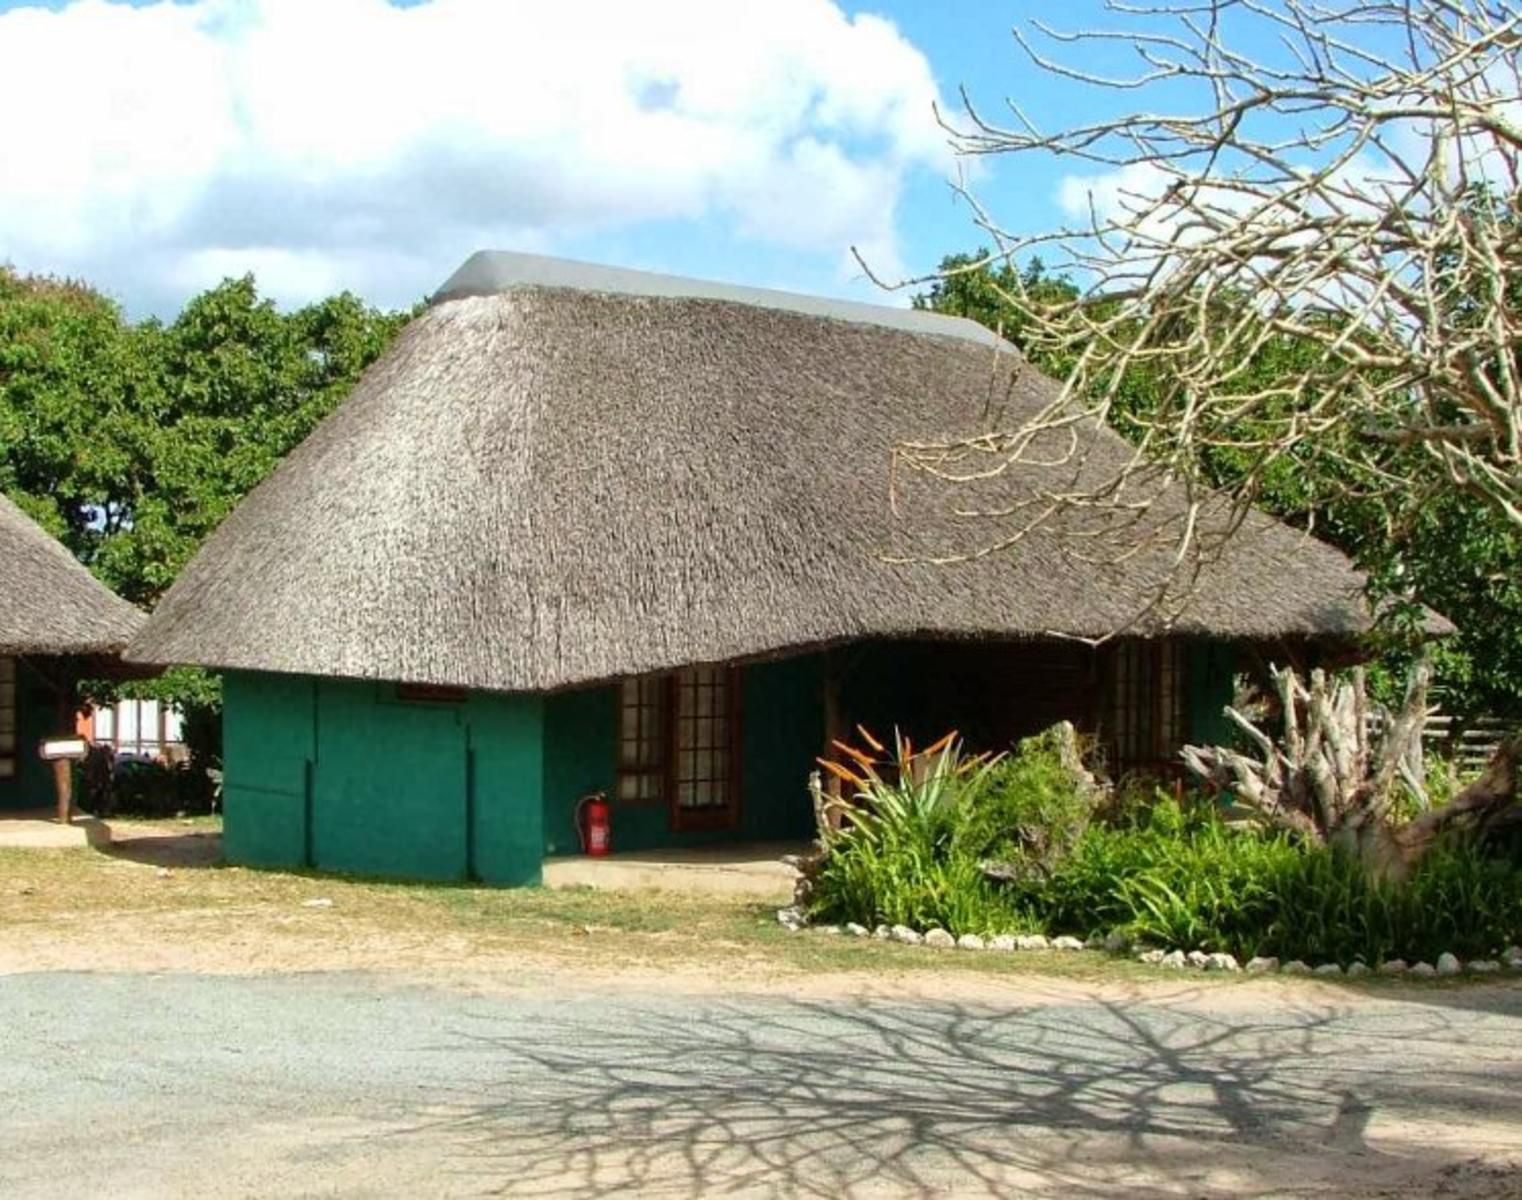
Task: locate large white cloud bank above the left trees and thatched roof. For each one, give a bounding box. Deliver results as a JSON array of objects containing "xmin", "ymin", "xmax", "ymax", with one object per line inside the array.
[{"xmin": 0, "ymin": 0, "xmax": 950, "ymax": 313}]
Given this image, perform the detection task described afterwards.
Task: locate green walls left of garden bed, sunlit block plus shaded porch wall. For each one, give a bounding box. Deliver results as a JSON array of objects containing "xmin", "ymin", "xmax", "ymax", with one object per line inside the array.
[{"xmin": 224, "ymin": 656, "xmax": 822, "ymax": 883}]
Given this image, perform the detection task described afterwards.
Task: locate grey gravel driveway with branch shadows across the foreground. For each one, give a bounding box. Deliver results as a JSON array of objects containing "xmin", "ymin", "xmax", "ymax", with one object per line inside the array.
[{"xmin": 0, "ymin": 973, "xmax": 1522, "ymax": 1197}]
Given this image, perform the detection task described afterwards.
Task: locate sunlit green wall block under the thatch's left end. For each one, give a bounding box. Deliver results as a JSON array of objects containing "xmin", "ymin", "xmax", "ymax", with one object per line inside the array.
[{"xmin": 222, "ymin": 672, "xmax": 543, "ymax": 883}]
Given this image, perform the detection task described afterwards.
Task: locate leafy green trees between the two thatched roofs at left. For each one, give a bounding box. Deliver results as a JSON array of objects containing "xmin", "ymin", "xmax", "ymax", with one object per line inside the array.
[{"xmin": 0, "ymin": 266, "xmax": 411, "ymax": 749}]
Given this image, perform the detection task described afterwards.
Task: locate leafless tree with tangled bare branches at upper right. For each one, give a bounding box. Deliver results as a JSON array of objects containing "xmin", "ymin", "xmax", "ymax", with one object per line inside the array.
[{"xmin": 895, "ymin": 0, "xmax": 1522, "ymax": 565}]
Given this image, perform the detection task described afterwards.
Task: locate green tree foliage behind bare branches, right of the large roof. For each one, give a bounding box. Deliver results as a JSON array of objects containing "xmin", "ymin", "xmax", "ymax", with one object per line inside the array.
[{"xmin": 915, "ymin": 248, "xmax": 1522, "ymax": 716}]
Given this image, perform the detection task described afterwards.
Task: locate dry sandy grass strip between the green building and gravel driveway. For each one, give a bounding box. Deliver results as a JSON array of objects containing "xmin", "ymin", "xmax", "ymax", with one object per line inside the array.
[{"xmin": 0, "ymin": 821, "xmax": 1491, "ymax": 991}]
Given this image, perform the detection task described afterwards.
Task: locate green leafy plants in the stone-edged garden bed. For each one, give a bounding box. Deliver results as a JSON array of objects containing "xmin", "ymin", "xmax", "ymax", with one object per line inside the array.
[{"xmin": 811, "ymin": 715, "xmax": 1522, "ymax": 964}]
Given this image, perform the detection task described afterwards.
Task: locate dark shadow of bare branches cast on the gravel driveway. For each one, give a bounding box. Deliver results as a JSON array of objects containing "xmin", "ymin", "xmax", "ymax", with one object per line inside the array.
[{"xmin": 395, "ymin": 1001, "xmax": 1522, "ymax": 1198}]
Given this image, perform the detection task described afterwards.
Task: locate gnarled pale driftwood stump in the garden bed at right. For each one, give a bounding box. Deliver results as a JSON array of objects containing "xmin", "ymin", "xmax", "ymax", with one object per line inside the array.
[{"xmin": 1183, "ymin": 662, "xmax": 1522, "ymax": 876}]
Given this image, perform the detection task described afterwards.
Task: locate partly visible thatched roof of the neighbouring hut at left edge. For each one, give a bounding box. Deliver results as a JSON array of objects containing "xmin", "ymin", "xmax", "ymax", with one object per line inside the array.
[{"xmin": 0, "ymin": 495, "xmax": 143, "ymax": 655}]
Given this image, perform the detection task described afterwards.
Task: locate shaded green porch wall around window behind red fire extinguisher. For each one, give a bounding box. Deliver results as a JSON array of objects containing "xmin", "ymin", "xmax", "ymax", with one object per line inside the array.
[{"xmin": 545, "ymin": 655, "xmax": 825, "ymax": 854}]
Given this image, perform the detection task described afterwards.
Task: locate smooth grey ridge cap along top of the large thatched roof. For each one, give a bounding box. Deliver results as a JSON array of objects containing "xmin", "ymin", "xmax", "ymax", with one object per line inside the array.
[{"xmin": 429, "ymin": 250, "xmax": 1008, "ymax": 347}]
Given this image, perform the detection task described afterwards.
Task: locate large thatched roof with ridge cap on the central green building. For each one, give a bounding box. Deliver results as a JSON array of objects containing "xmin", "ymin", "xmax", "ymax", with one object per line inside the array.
[{"xmin": 129, "ymin": 256, "xmax": 1394, "ymax": 690}]
